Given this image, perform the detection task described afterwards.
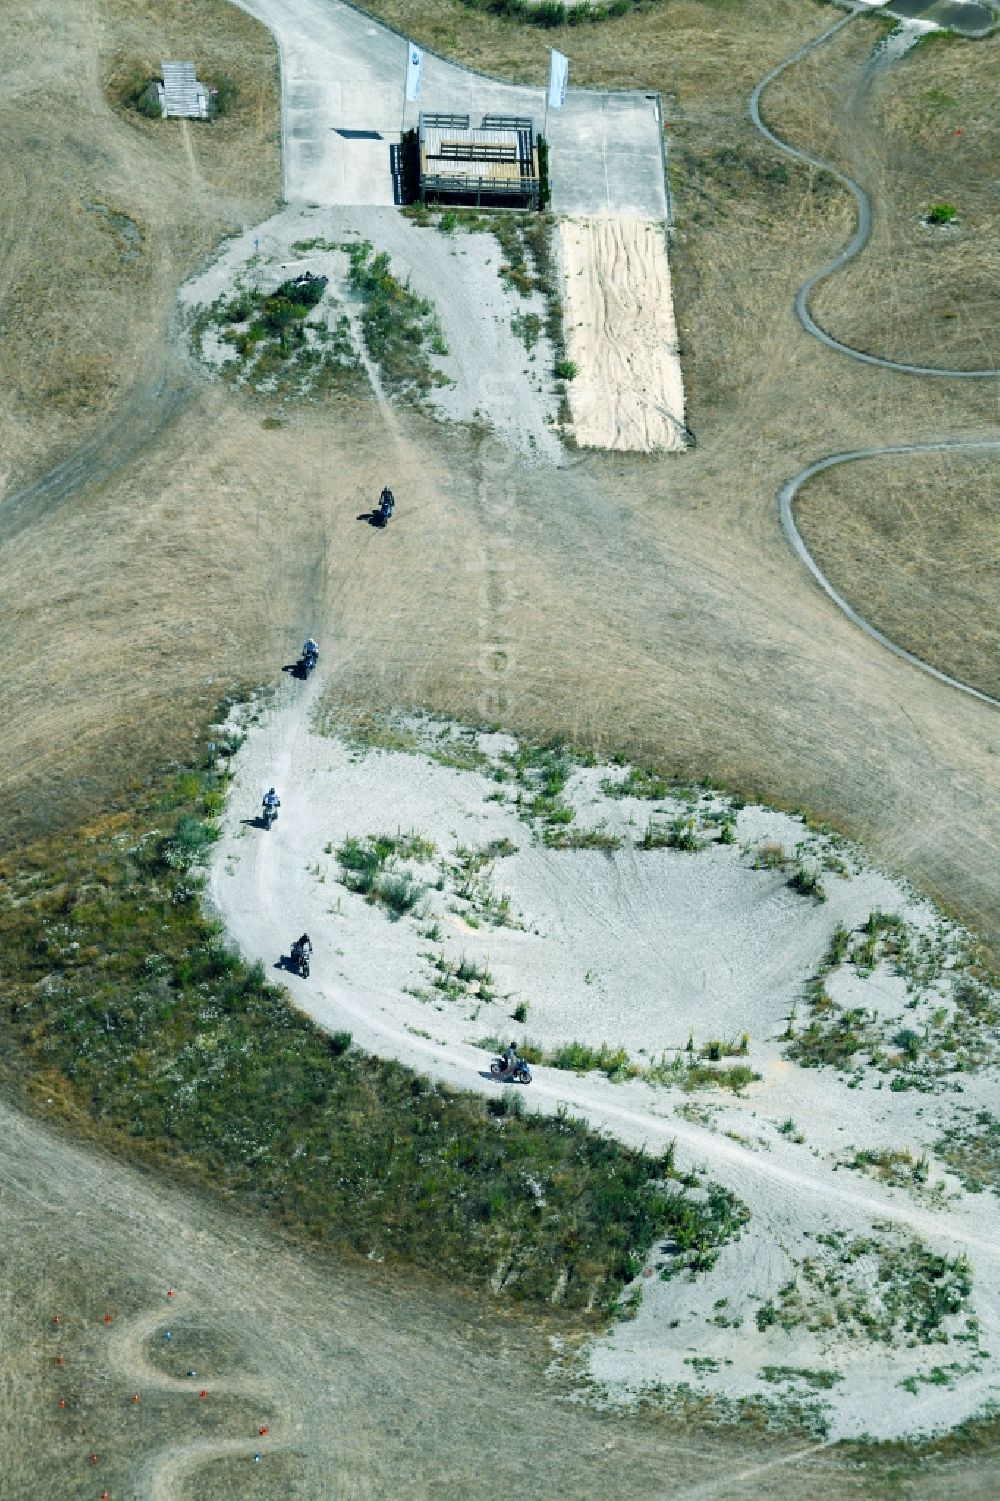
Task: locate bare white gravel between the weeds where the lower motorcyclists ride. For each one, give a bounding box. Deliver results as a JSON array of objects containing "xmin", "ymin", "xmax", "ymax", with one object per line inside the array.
[{"xmin": 210, "ymin": 680, "xmax": 1000, "ymax": 1438}]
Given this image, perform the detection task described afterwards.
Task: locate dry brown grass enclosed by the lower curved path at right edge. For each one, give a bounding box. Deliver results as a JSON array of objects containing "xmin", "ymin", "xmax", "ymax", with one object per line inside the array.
[{"xmin": 796, "ymin": 453, "xmax": 1000, "ymax": 696}]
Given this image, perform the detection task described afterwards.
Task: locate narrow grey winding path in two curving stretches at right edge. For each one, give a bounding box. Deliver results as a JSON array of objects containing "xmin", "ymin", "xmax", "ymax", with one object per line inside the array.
[{"xmin": 749, "ymin": 12, "xmax": 1000, "ymax": 708}]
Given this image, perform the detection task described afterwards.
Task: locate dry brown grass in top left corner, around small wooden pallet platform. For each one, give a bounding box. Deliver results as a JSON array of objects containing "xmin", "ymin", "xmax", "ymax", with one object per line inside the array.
[{"xmin": 0, "ymin": 0, "xmax": 281, "ymax": 483}]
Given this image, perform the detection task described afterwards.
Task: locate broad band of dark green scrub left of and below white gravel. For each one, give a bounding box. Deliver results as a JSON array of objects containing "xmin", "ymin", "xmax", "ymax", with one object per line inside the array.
[{"xmin": 0, "ymin": 735, "xmax": 747, "ymax": 1312}]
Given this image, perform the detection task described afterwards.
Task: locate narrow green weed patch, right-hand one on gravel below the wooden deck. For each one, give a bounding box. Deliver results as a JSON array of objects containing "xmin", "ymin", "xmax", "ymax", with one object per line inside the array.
[{"xmin": 341, "ymin": 240, "xmax": 447, "ymax": 401}]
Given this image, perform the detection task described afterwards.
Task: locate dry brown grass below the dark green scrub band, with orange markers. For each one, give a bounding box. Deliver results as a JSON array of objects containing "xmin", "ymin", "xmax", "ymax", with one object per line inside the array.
[{"xmin": 0, "ymin": 1096, "xmax": 991, "ymax": 1501}]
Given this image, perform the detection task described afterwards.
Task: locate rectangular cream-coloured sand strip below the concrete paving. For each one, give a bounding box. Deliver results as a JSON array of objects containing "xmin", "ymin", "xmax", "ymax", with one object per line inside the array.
[{"xmin": 559, "ymin": 218, "xmax": 686, "ymax": 453}]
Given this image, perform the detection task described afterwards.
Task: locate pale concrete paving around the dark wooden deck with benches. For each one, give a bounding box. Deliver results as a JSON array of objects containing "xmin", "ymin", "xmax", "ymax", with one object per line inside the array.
[{"xmin": 237, "ymin": 0, "xmax": 667, "ymax": 219}]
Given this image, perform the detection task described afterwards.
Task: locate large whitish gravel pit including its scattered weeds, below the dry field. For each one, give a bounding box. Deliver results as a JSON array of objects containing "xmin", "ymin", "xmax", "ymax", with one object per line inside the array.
[{"xmin": 210, "ymin": 681, "xmax": 1000, "ymax": 1439}]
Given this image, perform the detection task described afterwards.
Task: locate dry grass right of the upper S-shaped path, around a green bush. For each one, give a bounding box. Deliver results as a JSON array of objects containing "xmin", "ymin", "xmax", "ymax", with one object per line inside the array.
[{"xmin": 764, "ymin": 15, "xmax": 1000, "ymax": 369}]
